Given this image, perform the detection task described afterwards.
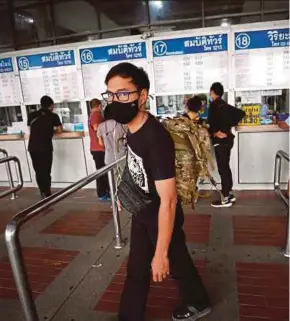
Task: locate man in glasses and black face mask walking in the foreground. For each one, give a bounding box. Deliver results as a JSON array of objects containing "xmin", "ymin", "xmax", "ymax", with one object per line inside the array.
[{"xmin": 103, "ymin": 63, "xmax": 210, "ymax": 321}]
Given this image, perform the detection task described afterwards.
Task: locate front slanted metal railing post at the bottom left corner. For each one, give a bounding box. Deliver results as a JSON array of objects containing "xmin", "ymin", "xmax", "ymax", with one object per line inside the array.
[{"xmin": 5, "ymin": 221, "xmax": 39, "ymax": 321}]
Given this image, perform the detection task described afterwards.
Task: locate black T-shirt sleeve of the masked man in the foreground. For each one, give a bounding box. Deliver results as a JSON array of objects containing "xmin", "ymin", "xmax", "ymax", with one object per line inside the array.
[{"xmin": 149, "ymin": 128, "xmax": 175, "ymax": 181}]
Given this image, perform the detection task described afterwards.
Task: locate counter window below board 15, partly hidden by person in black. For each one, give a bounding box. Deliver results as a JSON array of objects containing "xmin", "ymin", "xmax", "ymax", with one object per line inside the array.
[{"xmin": 26, "ymin": 102, "xmax": 84, "ymax": 132}]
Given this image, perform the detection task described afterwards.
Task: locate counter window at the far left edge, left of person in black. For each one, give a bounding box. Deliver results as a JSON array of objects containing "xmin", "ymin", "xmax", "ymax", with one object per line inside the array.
[{"xmin": 0, "ymin": 106, "xmax": 25, "ymax": 134}]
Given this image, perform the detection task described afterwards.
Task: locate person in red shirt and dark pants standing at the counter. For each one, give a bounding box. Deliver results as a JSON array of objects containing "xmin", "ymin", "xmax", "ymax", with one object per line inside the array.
[{"xmin": 88, "ymin": 98, "xmax": 109, "ymax": 201}]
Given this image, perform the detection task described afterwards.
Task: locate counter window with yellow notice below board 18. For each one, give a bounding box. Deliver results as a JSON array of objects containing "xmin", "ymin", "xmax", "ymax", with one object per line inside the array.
[{"xmin": 235, "ymin": 89, "xmax": 289, "ymax": 125}]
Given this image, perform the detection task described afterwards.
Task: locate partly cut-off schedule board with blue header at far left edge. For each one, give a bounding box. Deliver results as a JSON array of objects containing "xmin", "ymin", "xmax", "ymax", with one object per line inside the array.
[{"xmin": 0, "ymin": 58, "xmax": 19, "ymax": 106}]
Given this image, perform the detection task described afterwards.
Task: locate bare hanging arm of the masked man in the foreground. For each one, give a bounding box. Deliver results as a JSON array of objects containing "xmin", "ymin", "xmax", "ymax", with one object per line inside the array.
[{"xmin": 152, "ymin": 177, "xmax": 177, "ymax": 282}]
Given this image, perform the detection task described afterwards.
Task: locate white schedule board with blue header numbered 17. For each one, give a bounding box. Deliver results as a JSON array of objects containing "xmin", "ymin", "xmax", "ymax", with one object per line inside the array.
[{"xmin": 152, "ymin": 34, "xmax": 228, "ymax": 94}]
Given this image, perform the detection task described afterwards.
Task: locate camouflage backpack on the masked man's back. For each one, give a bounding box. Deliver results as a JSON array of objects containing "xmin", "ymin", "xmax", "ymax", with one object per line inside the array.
[{"xmin": 163, "ymin": 116, "xmax": 216, "ymax": 208}]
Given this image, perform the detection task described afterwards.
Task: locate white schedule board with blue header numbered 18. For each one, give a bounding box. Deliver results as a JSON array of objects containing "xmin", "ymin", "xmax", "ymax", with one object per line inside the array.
[{"xmin": 235, "ymin": 28, "xmax": 289, "ymax": 90}]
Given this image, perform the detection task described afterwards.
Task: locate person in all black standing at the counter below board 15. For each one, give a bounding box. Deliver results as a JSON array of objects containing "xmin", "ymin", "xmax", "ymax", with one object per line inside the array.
[{"xmin": 27, "ymin": 96, "xmax": 62, "ymax": 198}]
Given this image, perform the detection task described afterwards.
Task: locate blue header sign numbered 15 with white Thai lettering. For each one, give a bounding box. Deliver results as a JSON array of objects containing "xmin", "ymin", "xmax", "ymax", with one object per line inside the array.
[{"xmin": 17, "ymin": 50, "xmax": 75, "ymax": 71}]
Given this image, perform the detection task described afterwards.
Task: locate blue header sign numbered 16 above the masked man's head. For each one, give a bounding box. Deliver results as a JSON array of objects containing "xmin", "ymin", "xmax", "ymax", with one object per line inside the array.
[{"xmin": 80, "ymin": 42, "xmax": 147, "ymax": 65}]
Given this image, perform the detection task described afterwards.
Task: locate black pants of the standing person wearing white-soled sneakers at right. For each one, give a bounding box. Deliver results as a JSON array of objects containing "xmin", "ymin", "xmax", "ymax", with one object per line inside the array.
[{"xmin": 214, "ymin": 140, "xmax": 234, "ymax": 197}]
